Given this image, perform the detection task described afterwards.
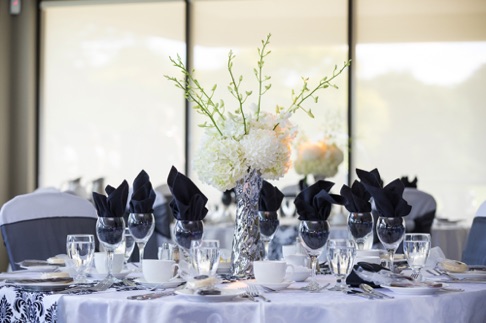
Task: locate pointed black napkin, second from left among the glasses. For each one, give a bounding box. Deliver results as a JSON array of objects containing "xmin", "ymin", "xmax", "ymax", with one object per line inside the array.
[{"xmin": 129, "ymin": 169, "xmax": 155, "ymax": 213}]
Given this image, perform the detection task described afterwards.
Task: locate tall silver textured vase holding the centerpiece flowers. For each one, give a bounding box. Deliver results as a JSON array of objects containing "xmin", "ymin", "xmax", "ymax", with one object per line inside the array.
[{"xmin": 231, "ymin": 169, "xmax": 263, "ymax": 278}]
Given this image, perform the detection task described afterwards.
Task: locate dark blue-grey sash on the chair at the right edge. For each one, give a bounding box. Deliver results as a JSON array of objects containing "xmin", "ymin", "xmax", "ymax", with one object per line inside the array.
[{"xmin": 462, "ymin": 216, "xmax": 486, "ymax": 266}]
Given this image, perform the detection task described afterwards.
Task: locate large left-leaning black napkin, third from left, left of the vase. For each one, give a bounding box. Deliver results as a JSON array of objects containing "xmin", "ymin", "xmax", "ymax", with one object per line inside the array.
[{"xmin": 167, "ymin": 166, "xmax": 208, "ymax": 221}]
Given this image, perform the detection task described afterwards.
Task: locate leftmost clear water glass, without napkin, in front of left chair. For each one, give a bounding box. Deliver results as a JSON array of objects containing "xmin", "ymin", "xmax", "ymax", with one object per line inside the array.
[{"xmin": 66, "ymin": 234, "xmax": 95, "ymax": 283}]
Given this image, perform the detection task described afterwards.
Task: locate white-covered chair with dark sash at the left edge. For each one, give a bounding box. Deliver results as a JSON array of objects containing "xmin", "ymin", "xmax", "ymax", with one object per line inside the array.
[{"xmin": 0, "ymin": 189, "xmax": 98, "ymax": 270}]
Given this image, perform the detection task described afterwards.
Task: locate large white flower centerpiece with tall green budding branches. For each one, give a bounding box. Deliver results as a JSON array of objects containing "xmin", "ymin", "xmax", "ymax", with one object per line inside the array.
[{"xmin": 165, "ymin": 34, "xmax": 350, "ymax": 191}]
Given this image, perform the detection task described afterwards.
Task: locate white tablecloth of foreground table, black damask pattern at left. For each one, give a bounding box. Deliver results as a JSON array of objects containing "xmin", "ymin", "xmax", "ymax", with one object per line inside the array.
[{"xmin": 0, "ymin": 275, "xmax": 486, "ymax": 323}]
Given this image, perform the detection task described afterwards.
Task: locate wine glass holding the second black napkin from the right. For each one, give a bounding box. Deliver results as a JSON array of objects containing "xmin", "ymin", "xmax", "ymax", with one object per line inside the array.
[{"xmin": 348, "ymin": 212, "xmax": 374, "ymax": 250}]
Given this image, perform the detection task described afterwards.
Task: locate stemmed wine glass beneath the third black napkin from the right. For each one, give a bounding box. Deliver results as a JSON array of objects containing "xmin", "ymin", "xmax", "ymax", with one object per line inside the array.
[{"xmin": 299, "ymin": 220, "xmax": 330, "ymax": 291}]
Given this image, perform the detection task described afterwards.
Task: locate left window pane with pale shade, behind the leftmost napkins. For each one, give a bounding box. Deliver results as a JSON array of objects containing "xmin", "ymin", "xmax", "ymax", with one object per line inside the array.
[{"xmin": 39, "ymin": 1, "xmax": 185, "ymax": 192}]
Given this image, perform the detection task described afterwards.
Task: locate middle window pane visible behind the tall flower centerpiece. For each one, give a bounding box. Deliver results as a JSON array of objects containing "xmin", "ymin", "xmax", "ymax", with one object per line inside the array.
[{"xmin": 186, "ymin": 0, "xmax": 348, "ymax": 202}]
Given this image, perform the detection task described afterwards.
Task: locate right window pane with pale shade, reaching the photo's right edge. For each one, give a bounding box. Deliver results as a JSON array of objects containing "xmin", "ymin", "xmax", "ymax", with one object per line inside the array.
[{"xmin": 353, "ymin": 0, "xmax": 486, "ymax": 220}]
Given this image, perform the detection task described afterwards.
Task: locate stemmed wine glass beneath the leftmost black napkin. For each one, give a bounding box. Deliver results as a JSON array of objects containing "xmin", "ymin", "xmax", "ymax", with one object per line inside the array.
[{"xmin": 96, "ymin": 217, "xmax": 125, "ymax": 282}]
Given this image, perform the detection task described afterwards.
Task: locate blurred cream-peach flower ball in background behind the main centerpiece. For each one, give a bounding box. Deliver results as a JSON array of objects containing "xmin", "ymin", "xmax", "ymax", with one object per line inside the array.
[{"xmin": 294, "ymin": 139, "xmax": 344, "ymax": 178}]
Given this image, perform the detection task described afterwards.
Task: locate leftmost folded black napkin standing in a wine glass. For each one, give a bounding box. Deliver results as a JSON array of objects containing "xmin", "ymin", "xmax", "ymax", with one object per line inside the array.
[{"xmin": 93, "ymin": 180, "xmax": 128, "ymax": 218}]
